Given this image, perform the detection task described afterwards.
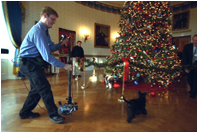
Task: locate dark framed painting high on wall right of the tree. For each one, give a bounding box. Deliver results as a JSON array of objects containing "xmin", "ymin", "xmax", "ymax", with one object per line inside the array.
[{"xmin": 172, "ymin": 11, "xmax": 190, "ymax": 31}]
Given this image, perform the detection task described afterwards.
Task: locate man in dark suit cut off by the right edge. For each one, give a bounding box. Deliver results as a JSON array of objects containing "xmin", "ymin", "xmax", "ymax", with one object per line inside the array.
[{"xmin": 182, "ymin": 35, "xmax": 197, "ymax": 98}]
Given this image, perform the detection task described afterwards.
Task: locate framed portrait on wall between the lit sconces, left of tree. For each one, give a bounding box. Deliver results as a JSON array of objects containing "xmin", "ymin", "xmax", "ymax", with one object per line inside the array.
[{"xmin": 94, "ymin": 23, "xmax": 110, "ymax": 48}]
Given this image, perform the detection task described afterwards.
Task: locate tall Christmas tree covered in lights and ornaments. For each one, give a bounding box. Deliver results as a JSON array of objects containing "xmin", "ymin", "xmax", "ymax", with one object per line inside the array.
[{"xmin": 105, "ymin": 1, "xmax": 181, "ymax": 88}]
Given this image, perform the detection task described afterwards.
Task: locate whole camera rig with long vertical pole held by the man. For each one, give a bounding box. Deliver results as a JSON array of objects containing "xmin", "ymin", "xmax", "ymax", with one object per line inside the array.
[{"xmin": 58, "ymin": 34, "xmax": 78, "ymax": 118}]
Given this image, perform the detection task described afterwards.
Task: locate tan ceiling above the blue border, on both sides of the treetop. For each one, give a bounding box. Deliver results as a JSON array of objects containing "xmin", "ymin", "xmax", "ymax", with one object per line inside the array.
[{"xmin": 97, "ymin": 1, "xmax": 186, "ymax": 8}]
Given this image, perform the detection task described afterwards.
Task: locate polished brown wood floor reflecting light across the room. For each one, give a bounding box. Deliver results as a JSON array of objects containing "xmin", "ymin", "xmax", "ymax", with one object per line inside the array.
[{"xmin": 1, "ymin": 69, "xmax": 197, "ymax": 132}]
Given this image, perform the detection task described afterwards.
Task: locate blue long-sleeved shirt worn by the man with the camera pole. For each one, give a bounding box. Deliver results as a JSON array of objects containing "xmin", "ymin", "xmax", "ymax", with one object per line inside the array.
[{"xmin": 19, "ymin": 21, "xmax": 65, "ymax": 68}]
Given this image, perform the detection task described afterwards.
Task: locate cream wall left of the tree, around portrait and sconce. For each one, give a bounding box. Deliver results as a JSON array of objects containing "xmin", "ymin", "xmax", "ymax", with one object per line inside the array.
[{"xmin": 22, "ymin": 1, "xmax": 119, "ymax": 55}]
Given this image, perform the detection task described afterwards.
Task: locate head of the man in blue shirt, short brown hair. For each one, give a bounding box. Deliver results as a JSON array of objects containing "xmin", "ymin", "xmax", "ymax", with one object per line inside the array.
[{"xmin": 40, "ymin": 6, "xmax": 58, "ymax": 29}]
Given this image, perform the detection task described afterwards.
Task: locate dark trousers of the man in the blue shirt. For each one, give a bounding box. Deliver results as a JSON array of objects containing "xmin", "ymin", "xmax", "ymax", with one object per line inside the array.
[{"xmin": 19, "ymin": 58, "xmax": 57, "ymax": 116}]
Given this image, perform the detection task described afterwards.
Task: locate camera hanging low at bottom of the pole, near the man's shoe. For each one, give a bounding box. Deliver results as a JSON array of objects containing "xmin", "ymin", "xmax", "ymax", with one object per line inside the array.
[{"xmin": 58, "ymin": 101, "xmax": 78, "ymax": 118}]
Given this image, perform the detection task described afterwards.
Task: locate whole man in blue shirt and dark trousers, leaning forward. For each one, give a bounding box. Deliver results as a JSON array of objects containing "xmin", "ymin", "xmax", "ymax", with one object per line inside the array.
[{"xmin": 19, "ymin": 7, "xmax": 72, "ymax": 123}]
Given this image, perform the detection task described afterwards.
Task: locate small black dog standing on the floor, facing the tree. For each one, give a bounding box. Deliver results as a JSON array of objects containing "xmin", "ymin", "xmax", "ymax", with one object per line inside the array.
[{"xmin": 123, "ymin": 91, "xmax": 147, "ymax": 123}]
